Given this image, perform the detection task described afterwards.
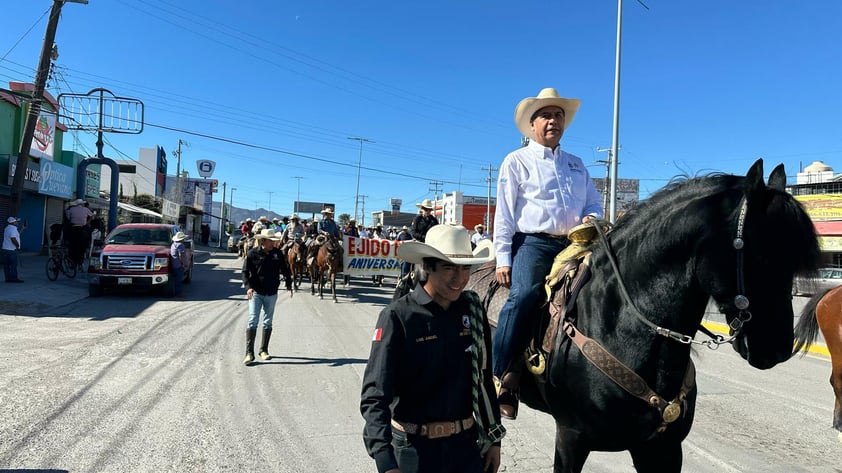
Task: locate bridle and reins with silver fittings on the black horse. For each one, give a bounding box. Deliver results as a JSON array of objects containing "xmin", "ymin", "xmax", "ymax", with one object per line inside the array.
[{"xmin": 594, "ymin": 196, "xmax": 751, "ymax": 350}]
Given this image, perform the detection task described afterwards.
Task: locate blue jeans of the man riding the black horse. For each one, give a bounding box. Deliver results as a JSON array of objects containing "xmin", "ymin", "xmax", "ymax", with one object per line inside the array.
[{"xmin": 492, "ymin": 233, "xmax": 570, "ymax": 378}]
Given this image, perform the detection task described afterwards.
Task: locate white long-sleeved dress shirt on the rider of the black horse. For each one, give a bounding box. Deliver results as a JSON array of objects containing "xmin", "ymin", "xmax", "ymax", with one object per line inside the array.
[{"xmin": 494, "ymin": 141, "xmax": 602, "ymax": 267}]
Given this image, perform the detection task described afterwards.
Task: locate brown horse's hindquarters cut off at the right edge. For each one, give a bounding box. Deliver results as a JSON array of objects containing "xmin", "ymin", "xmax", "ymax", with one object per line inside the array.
[{"xmin": 794, "ymin": 286, "xmax": 842, "ymax": 434}]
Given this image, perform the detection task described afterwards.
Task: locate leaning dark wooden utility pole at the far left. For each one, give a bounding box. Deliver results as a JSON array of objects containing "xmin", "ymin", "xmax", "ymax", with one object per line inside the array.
[{"xmin": 9, "ymin": 0, "xmax": 88, "ymax": 215}]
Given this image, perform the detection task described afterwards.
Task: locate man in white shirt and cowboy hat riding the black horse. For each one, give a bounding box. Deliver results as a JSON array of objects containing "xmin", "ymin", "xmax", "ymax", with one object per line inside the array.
[{"xmin": 492, "ymin": 88, "xmax": 602, "ymax": 419}]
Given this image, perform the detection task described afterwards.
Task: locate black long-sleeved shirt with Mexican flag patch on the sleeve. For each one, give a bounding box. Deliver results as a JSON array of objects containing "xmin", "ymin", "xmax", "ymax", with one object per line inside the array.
[{"xmin": 360, "ymin": 288, "xmax": 500, "ymax": 472}]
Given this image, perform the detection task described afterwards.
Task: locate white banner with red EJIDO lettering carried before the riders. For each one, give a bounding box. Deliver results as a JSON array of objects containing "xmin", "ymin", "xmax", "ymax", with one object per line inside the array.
[{"xmin": 342, "ymin": 235, "xmax": 403, "ymax": 276}]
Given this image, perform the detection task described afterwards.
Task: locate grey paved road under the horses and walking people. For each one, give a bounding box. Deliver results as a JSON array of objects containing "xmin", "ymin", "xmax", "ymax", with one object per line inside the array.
[{"xmin": 0, "ymin": 249, "xmax": 842, "ymax": 473}]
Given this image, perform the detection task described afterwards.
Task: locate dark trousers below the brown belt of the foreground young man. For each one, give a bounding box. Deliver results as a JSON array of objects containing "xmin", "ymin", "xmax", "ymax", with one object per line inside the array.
[{"xmin": 392, "ymin": 428, "xmax": 484, "ymax": 473}]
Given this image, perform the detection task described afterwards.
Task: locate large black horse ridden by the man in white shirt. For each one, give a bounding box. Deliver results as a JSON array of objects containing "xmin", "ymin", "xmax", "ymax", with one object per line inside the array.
[{"xmin": 462, "ymin": 160, "xmax": 820, "ymax": 473}]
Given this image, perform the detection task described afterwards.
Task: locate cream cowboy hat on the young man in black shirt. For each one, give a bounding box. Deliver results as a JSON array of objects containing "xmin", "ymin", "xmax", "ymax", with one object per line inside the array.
[{"xmin": 398, "ymin": 225, "xmax": 494, "ymax": 265}]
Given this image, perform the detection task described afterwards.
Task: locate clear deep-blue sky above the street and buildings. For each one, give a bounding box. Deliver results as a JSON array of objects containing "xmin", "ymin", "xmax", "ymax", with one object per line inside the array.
[{"xmin": 0, "ymin": 0, "xmax": 842, "ymax": 218}]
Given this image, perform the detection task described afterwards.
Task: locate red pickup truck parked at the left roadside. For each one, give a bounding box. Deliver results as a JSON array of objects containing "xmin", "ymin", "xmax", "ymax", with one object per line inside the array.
[{"xmin": 88, "ymin": 223, "xmax": 193, "ymax": 297}]
